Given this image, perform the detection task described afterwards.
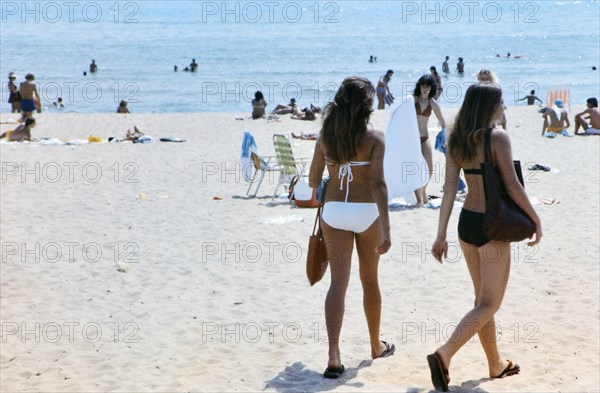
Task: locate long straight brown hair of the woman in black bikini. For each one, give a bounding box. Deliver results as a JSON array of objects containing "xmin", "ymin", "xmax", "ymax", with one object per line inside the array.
[{"xmin": 448, "ymin": 83, "xmax": 503, "ymax": 162}]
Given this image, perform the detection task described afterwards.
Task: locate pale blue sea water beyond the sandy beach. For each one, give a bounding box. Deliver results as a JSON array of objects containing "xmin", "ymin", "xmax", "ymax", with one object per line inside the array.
[{"xmin": 0, "ymin": 1, "xmax": 600, "ymax": 113}]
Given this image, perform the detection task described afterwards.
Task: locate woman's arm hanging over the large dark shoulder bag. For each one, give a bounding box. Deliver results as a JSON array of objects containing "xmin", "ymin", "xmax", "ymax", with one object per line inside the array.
[{"xmin": 491, "ymin": 131, "xmax": 542, "ymax": 246}]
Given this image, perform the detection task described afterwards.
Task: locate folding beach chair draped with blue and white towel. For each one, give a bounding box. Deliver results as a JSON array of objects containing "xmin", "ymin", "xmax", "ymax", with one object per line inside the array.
[{"xmin": 241, "ymin": 131, "xmax": 281, "ymax": 198}]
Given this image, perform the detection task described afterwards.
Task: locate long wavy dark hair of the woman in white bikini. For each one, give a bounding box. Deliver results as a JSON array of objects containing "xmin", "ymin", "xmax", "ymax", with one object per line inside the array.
[{"xmin": 320, "ymin": 76, "xmax": 375, "ymax": 164}]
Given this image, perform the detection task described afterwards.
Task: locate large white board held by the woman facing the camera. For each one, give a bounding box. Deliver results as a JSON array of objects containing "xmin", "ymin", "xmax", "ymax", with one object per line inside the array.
[{"xmin": 383, "ymin": 95, "xmax": 429, "ymax": 204}]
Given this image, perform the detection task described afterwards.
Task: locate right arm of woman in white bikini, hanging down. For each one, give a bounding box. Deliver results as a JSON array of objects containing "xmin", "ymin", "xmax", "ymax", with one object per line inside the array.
[{"xmin": 370, "ymin": 131, "xmax": 392, "ymax": 254}]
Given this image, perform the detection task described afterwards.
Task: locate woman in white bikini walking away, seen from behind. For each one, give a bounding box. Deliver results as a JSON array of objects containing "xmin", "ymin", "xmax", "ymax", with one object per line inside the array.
[{"xmin": 309, "ymin": 77, "xmax": 396, "ymax": 378}]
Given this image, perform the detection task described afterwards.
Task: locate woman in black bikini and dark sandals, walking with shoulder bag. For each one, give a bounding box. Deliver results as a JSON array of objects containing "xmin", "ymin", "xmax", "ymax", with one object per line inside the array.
[{"xmin": 427, "ymin": 83, "xmax": 542, "ymax": 391}]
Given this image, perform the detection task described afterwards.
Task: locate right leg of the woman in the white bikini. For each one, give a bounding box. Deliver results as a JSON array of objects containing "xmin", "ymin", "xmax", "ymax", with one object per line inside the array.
[{"xmin": 356, "ymin": 218, "xmax": 386, "ymax": 359}]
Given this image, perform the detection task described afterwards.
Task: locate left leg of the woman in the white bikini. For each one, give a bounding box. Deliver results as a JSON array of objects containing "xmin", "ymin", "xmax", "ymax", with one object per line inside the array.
[{"xmin": 321, "ymin": 220, "xmax": 354, "ymax": 368}]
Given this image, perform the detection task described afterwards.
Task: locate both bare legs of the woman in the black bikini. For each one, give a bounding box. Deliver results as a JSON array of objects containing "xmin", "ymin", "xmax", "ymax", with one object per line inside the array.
[{"xmin": 437, "ymin": 241, "xmax": 510, "ymax": 376}]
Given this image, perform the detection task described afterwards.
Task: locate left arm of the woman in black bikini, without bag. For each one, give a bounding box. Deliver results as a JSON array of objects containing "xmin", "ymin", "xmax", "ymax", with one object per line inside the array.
[{"xmin": 431, "ymin": 154, "xmax": 460, "ymax": 262}]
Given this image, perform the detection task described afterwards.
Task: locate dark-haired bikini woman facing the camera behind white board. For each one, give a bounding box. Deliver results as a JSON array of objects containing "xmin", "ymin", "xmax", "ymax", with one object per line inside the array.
[{"xmin": 413, "ymin": 75, "xmax": 446, "ymax": 206}]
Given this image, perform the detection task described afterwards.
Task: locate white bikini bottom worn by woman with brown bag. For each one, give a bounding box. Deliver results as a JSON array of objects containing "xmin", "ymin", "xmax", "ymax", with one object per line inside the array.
[{"xmin": 321, "ymin": 202, "xmax": 379, "ymax": 233}]
